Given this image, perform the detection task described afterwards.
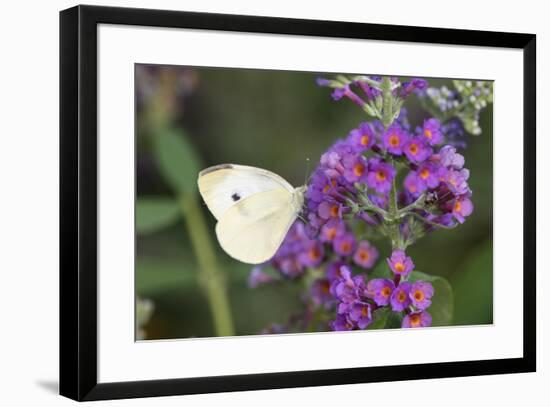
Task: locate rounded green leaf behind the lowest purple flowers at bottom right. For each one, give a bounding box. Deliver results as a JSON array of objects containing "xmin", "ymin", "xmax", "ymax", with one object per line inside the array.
[{"xmin": 409, "ymin": 270, "xmax": 454, "ymax": 326}]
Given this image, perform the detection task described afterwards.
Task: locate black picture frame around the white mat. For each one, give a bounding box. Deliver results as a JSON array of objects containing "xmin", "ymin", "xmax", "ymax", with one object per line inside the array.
[{"xmin": 60, "ymin": 6, "xmax": 536, "ymax": 401}]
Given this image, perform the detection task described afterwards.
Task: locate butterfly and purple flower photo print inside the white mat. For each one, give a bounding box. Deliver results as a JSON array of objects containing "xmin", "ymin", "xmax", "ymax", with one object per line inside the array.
[{"xmin": 135, "ymin": 64, "xmax": 493, "ymax": 340}]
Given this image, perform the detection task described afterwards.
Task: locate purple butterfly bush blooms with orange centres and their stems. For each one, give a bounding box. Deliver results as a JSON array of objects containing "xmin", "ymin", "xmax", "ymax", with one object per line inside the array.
[{"xmin": 250, "ymin": 75, "xmax": 489, "ymax": 332}]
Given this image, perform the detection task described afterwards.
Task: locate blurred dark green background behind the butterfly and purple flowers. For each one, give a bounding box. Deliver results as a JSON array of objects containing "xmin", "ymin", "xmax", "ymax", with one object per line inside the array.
[{"xmin": 135, "ymin": 64, "xmax": 493, "ymax": 339}]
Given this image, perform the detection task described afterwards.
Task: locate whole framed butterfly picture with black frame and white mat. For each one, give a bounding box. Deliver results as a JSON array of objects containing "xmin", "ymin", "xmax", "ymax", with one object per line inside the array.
[{"xmin": 60, "ymin": 6, "xmax": 536, "ymax": 400}]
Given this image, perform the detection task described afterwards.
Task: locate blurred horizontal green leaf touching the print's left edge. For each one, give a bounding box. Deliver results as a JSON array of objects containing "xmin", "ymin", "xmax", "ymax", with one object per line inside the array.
[{"xmin": 136, "ymin": 197, "xmax": 179, "ymax": 235}]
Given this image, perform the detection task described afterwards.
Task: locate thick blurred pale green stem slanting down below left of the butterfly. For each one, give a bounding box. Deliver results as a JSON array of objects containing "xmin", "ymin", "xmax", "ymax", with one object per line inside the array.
[{"xmin": 179, "ymin": 194, "xmax": 235, "ymax": 336}]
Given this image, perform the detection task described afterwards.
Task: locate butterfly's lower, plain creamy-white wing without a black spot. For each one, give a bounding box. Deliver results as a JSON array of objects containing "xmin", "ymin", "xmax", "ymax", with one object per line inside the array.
[{"xmin": 216, "ymin": 188, "xmax": 303, "ymax": 264}]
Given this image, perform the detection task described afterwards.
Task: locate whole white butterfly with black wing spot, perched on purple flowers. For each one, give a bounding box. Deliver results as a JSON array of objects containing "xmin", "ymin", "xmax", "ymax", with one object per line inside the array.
[{"xmin": 198, "ymin": 164, "xmax": 306, "ymax": 264}]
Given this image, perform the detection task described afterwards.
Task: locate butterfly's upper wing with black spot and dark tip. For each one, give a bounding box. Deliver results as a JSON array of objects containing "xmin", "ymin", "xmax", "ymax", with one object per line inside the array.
[{"xmin": 198, "ymin": 164, "xmax": 293, "ymax": 220}]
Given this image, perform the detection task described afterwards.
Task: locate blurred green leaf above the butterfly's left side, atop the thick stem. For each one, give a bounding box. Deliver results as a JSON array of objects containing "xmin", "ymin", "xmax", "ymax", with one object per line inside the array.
[{"xmin": 152, "ymin": 128, "xmax": 202, "ymax": 194}]
